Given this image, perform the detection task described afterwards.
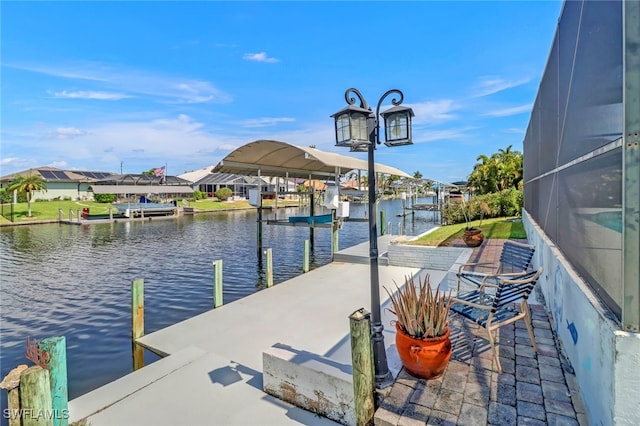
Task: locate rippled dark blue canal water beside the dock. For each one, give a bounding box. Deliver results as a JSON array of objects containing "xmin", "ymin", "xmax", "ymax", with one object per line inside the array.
[{"xmin": 0, "ymin": 200, "xmax": 437, "ymax": 410}]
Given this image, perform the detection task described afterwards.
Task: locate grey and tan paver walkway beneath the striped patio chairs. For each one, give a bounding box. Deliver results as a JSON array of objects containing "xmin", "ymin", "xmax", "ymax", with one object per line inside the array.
[{"xmin": 374, "ymin": 239, "xmax": 588, "ymax": 426}]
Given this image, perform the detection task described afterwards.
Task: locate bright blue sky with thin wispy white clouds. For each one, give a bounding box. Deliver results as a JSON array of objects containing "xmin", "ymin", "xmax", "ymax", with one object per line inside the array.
[{"xmin": 0, "ymin": 0, "xmax": 562, "ymax": 182}]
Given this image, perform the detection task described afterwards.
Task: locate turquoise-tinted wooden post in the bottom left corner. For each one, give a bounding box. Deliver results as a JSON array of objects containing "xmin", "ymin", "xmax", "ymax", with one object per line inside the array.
[{"xmin": 38, "ymin": 336, "xmax": 69, "ymax": 426}]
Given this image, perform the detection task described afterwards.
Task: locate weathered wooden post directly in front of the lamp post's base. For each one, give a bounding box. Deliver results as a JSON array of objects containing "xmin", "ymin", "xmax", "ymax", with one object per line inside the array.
[{"xmin": 349, "ymin": 308, "xmax": 375, "ymax": 426}]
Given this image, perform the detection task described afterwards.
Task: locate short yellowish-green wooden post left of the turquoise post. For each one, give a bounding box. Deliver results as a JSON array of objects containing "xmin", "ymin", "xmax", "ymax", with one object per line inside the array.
[{"xmin": 20, "ymin": 365, "xmax": 53, "ymax": 426}]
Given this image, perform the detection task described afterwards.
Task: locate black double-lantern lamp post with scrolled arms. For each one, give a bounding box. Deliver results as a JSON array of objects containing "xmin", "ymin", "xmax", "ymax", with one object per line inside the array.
[{"xmin": 331, "ymin": 88, "xmax": 414, "ymax": 389}]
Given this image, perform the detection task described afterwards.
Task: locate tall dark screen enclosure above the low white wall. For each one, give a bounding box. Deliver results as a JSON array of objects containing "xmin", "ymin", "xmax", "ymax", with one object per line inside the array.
[{"xmin": 524, "ymin": 1, "xmax": 640, "ymax": 332}]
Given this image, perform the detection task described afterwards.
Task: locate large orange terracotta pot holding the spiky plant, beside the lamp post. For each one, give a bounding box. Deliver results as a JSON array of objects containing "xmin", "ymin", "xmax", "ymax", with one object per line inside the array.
[{"xmin": 396, "ymin": 323, "xmax": 452, "ymax": 379}]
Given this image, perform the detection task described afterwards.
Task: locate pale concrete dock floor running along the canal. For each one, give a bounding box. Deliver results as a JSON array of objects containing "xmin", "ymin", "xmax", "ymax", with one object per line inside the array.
[{"xmin": 69, "ymin": 236, "xmax": 460, "ymax": 426}]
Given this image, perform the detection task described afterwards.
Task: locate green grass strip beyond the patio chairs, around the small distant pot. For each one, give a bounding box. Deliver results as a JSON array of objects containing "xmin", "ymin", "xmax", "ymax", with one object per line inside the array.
[{"xmin": 407, "ymin": 217, "xmax": 527, "ymax": 246}]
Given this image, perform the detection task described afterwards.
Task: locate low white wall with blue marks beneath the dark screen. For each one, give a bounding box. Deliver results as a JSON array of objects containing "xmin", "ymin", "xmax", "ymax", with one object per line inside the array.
[{"xmin": 523, "ymin": 211, "xmax": 640, "ymax": 425}]
